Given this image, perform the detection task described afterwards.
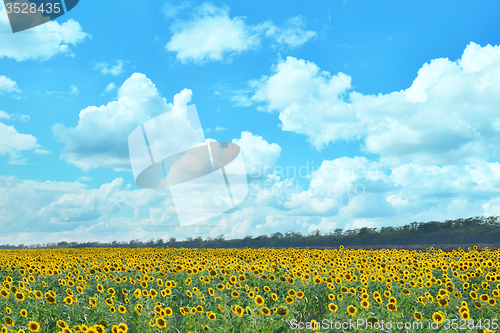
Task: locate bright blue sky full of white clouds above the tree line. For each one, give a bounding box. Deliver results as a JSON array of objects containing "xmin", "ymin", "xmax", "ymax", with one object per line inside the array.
[{"xmin": 0, "ymin": 0, "xmax": 500, "ymax": 244}]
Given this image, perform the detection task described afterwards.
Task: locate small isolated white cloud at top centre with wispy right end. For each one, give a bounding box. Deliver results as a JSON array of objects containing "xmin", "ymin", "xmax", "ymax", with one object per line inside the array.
[{"xmin": 163, "ymin": 2, "xmax": 316, "ymax": 64}]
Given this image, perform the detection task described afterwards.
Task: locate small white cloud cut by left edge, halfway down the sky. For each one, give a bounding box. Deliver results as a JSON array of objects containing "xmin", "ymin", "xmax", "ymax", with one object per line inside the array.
[{"xmin": 0, "ymin": 121, "xmax": 48, "ymax": 164}]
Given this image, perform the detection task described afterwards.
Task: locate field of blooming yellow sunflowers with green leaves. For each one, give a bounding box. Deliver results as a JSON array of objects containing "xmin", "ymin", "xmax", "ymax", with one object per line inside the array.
[{"xmin": 0, "ymin": 247, "xmax": 500, "ymax": 333}]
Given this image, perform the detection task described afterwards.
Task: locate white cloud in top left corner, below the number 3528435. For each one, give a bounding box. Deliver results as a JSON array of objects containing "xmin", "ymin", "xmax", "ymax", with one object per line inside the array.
[{"xmin": 0, "ymin": 2, "xmax": 91, "ymax": 61}]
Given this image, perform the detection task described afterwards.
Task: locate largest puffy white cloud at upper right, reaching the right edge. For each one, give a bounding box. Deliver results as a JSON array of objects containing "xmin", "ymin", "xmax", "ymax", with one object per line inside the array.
[{"xmin": 234, "ymin": 43, "xmax": 500, "ymax": 166}]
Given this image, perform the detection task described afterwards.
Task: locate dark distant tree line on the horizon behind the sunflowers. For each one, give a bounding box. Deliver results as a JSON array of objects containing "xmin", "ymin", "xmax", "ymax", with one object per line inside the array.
[{"xmin": 0, "ymin": 216, "xmax": 500, "ymax": 249}]
